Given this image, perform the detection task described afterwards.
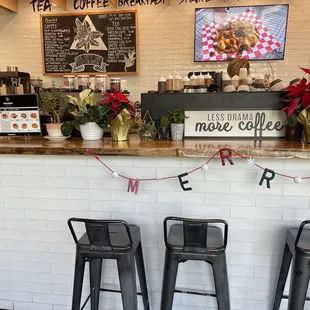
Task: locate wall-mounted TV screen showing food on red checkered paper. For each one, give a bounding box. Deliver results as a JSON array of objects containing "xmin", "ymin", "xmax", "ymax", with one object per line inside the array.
[{"xmin": 195, "ymin": 4, "xmax": 289, "ymax": 62}]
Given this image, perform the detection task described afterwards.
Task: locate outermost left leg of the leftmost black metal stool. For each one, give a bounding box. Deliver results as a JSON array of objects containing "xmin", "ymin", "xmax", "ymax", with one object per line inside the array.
[{"xmin": 71, "ymin": 252, "xmax": 85, "ymax": 310}]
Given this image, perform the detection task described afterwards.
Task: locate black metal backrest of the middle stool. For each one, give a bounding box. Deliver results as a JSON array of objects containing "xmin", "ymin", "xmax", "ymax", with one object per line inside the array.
[{"xmin": 164, "ymin": 216, "xmax": 228, "ymax": 253}]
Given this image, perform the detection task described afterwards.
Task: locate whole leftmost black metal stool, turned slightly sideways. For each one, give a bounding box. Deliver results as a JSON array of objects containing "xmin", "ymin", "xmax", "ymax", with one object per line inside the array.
[{"xmin": 68, "ymin": 218, "xmax": 150, "ymax": 310}]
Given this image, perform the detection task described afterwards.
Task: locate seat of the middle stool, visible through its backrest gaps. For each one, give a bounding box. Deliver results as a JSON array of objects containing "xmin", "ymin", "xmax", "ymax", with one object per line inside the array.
[{"xmin": 168, "ymin": 224, "xmax": 224, "ymax": 251}]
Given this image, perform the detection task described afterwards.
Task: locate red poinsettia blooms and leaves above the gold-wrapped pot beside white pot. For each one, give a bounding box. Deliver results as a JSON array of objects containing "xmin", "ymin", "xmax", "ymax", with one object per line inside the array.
[{"xmin": 98, "ymin": 91, "xmax": 136, "ymax": 120}]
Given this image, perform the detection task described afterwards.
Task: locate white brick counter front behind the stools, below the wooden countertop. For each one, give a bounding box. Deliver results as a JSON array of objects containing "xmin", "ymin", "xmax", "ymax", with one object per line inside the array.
[{"xmin": 0, "ymin": 155, "xmax": 310, "ymax": 310}]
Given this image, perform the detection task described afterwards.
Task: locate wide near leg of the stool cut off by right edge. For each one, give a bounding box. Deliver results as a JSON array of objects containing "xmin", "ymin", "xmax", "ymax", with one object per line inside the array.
[{"xmin": 287, "ymin": 252, "xmax": 310, "ymax": 310}]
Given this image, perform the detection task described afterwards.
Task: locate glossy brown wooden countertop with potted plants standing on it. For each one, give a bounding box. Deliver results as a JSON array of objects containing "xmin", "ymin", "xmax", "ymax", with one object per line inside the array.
[{"xmin": 0, "ymin": 135, "xmax": 310, "ymax": 159}]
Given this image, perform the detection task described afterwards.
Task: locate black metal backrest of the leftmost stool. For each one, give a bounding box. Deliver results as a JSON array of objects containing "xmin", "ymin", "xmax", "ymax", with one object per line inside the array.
[{"xmin": 68, "ymin": 218, "xmax": 132, "ymax": 251}]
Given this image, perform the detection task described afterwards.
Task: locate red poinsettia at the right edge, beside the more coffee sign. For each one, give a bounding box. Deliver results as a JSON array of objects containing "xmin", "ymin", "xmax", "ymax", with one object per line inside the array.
[{"xmin": 282, "ymin": 68, "xmax": 310, "ymax": 125}]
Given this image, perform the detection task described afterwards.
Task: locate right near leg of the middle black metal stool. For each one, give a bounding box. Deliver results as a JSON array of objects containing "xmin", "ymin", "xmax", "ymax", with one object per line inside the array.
[{"xmin": 212, "ymin": 254, "xmax": 230, "ymax": 310}]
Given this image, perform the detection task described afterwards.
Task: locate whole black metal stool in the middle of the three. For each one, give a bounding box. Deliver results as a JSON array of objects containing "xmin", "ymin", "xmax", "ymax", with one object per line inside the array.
[{"xmin": 160, "ymin": 217, "xmax": 230, "ymax": 310}]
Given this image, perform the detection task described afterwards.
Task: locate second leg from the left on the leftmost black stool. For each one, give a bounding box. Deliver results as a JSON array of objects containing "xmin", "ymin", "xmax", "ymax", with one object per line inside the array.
[{"xmin": 89, "ymin": 258, "xmax": 102, "ymax": 310}]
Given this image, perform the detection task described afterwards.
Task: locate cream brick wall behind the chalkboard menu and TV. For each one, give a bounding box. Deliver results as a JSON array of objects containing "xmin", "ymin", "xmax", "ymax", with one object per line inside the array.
[{"xmin": 0, "ymin": 0, "xmax": 310, "ymax": 101}]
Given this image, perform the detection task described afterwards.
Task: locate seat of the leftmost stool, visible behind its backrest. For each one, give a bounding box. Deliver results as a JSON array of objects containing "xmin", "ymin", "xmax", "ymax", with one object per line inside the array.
[{"xmin": 79, "ymin": 224, "xmax": 140, "ymax": 250}]
